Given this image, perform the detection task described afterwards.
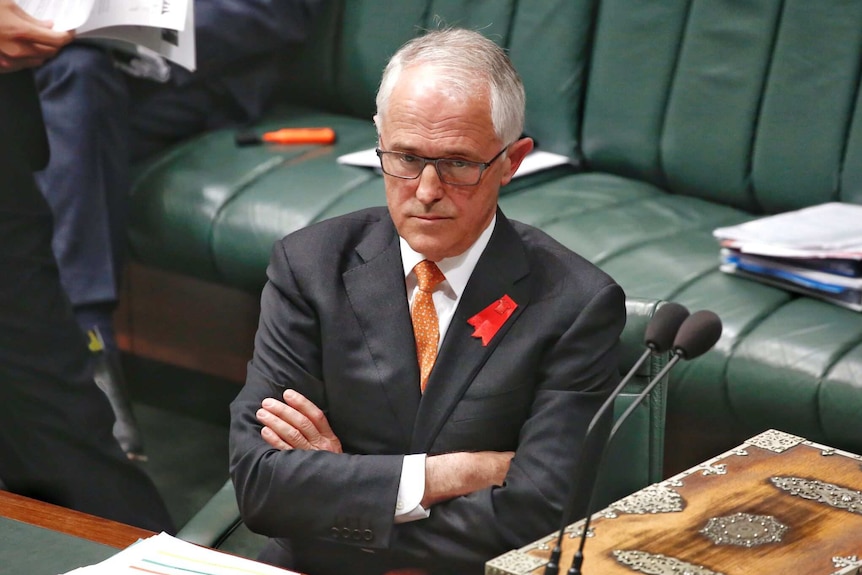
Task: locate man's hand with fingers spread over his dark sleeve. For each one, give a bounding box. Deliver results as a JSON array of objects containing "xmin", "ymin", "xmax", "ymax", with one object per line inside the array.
[{"xmin": 257, "ymin": 389, "xmax": 341, "ymax": 453}]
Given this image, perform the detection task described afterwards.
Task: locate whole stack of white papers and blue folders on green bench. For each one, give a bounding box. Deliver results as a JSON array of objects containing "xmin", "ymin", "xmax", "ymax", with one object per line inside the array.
[{"xmin": 713, "ymin": 202, "xmax": 862, "ymax": 311}]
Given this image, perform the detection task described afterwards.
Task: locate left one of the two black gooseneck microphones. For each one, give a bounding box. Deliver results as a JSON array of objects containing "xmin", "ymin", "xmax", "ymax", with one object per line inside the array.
[{"xmin": 545, "ymin": 302, "xmax": 689, "ymax": 575}]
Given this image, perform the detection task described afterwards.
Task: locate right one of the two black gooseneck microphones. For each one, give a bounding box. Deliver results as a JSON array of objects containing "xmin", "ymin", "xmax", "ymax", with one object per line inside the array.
[{"xmin": 567, "ymin": 310, "xmax": 722, "ymax": 575}]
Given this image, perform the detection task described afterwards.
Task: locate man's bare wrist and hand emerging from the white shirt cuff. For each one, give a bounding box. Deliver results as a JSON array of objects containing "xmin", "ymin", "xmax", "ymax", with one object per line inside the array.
[{"xmin": 421, "ymin": 451, "xmax": 515, "ymax": 509}]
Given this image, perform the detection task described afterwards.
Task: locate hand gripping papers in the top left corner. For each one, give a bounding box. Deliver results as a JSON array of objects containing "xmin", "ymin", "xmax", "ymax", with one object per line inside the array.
[{"xmin": 0, "ymin": 0, "xmax": 75, "ymax": 73}]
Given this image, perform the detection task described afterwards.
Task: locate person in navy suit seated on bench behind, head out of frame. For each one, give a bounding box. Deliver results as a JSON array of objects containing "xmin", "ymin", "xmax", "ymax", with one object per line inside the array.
[{"xmin": 36, "ymin": 0, "xmax": 322, "ymax": 458}]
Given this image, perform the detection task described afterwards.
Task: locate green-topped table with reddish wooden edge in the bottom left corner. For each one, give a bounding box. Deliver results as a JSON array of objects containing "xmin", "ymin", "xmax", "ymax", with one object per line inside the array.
[{"xmin": 0, "ymin": 491, "xmax": 155, "ymax": 575}]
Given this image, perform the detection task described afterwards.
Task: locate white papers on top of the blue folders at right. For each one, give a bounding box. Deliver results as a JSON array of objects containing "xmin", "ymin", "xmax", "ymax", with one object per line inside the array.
[{"xmin": 713, "ymin": 202, "xmax": 862, "ymax": 257}]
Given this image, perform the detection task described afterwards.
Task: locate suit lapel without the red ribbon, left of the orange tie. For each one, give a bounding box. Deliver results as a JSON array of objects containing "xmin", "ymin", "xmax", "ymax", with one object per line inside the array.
[{"xmin": 343, "ymin": 216, "xmax": 421, "ymax": 442}]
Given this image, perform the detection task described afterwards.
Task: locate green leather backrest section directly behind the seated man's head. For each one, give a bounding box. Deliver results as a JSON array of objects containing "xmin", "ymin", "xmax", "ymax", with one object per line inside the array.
[{"xmin": 281, "ymin": 0, "xmax": 594, "ymax": 156}]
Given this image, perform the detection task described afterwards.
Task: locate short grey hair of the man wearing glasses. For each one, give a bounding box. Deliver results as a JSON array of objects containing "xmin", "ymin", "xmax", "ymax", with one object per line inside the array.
[{"xmin": 377, "ymin": 28, "xmax": 526, "ymax": 144}]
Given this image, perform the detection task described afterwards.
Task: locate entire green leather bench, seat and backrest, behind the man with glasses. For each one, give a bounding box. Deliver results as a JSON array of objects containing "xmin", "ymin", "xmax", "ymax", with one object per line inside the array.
[{"xmin": 130, "ymin": 0, "xmax": 862, "ymax": 482}]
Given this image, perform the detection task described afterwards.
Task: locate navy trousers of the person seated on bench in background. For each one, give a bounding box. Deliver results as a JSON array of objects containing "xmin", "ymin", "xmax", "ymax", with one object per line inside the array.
[{"xmin": 36, "ymin": 43, "xmax": 245, "ymax": 307}]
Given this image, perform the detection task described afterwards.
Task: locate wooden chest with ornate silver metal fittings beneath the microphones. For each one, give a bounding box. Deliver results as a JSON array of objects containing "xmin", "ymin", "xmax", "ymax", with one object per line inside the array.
[{"xmin": 485, "ymin": 430, "xmax": 862, "ymax": 575}]
